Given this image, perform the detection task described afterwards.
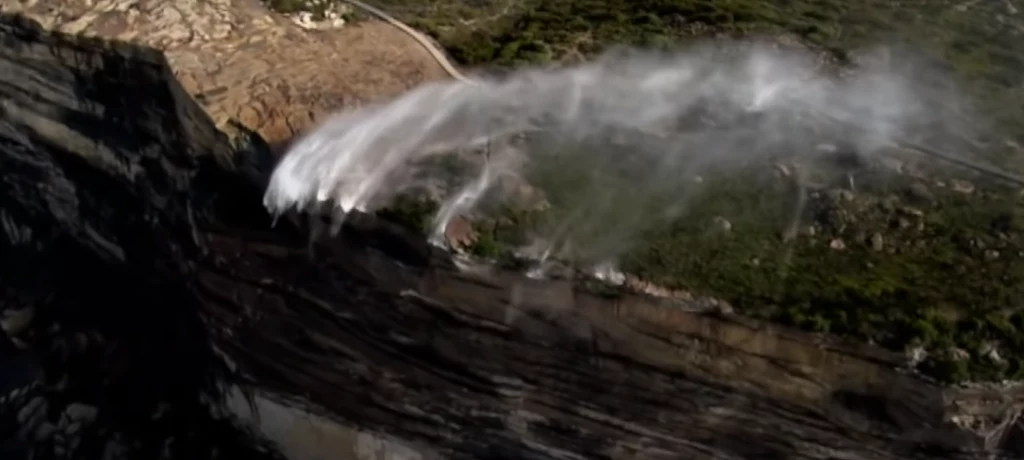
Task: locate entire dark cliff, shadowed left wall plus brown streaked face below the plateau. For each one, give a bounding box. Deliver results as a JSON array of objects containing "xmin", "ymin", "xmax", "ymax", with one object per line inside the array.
[{"xmin": 0, "ymin": 15, "xmax": 1024, "ymax": 459}]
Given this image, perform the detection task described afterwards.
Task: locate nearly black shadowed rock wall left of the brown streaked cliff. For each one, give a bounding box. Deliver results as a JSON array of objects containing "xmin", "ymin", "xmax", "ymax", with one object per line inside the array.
[{"xmin": 0, "ymin": 16, "xmax": 280, "ymax": 458}]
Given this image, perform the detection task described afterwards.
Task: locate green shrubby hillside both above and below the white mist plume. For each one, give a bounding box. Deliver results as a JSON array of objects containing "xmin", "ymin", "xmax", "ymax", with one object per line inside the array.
[{"xmin": 270, "ymin": 0, "xmax": 1024, "ymax": 381}]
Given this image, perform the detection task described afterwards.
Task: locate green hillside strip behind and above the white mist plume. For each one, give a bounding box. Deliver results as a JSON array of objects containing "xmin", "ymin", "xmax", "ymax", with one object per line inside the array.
[{"xmin": 374, "ymin": 0, "xmax": 1024, "ymax": 150}]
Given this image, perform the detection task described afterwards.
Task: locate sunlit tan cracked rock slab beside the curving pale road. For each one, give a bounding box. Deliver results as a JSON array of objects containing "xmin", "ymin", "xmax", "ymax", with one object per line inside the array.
[{"xmin": 0, "ymin": 0, "xmax": 446, "ymax": 143}]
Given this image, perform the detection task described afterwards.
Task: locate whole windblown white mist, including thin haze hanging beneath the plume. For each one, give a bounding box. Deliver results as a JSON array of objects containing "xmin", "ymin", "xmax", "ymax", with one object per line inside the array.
[{"xmin": 265, "ymin": 42, "xmax": 966, "ymax": 263}]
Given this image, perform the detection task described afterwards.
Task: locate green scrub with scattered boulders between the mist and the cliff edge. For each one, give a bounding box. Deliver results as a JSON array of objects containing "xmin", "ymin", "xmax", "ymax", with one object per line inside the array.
[{"xmin": 380, "ymin": 155, "xmax": 1024, "ymax": 382}]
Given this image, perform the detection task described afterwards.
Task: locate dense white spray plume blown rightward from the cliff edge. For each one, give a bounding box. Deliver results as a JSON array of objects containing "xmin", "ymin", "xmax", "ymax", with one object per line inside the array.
[{"xmin": 266, "ymin": 42, "xmax": 971, "ymax": 219}]
